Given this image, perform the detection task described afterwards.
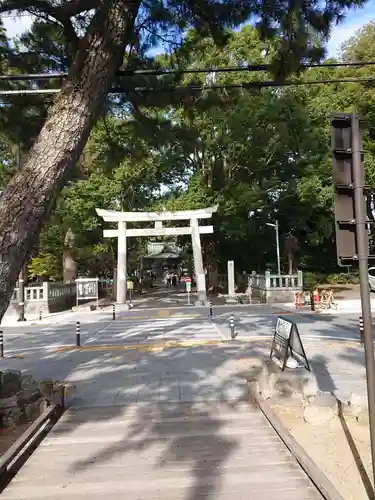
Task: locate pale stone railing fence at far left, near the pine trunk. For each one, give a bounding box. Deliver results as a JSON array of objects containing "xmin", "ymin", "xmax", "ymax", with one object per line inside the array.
[{"xmin": 6, "ymin": 282, "xmax": 76, "ymax": 318}]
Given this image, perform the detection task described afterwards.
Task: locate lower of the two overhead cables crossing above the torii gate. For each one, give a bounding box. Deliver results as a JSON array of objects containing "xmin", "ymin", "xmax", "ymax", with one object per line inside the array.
[{"xmin": 0, "ymin": 77, "xmax": 375, "ymax": 96}]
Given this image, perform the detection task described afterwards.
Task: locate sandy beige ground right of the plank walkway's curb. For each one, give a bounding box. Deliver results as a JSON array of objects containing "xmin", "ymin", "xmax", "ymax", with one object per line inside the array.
[{"xmin": 272, "ymin": 404, "xmax": 374, "ymax": 500}]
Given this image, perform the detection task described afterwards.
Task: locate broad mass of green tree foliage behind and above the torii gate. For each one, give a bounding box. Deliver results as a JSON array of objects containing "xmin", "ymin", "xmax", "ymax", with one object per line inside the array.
[{"xmin": 33, "ymin": 20, "xmax": 375, "ymax": 274}]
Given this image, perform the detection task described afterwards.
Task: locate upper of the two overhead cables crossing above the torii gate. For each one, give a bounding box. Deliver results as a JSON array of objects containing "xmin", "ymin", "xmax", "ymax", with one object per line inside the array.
[{"xmin": 0, "ymin": 61, "xmax": 375, "ymax": 81}]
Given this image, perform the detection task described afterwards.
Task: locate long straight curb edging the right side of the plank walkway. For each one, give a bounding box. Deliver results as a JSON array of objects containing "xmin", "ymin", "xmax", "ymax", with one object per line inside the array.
[{"xmin": 249, "ymin": 383, "xmax": 344, "ymax": 500}]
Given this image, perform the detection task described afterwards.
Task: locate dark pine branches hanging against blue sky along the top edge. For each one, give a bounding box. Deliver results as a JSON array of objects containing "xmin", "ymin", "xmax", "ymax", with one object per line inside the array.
[{"xmin": 142, "ymin": 0, "xmax": 365, "ymax": 77}]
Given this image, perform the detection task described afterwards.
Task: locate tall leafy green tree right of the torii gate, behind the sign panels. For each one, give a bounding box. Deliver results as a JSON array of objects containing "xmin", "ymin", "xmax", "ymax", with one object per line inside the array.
[{"xmin": 142, "ymin": 25, "xmax": 374, "ymax": 271}]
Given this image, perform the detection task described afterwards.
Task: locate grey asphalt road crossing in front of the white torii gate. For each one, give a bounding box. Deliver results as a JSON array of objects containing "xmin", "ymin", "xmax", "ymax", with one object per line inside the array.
[{"xmin": 2, "ymin": 305, "xmax": 370, "ymax": 354}]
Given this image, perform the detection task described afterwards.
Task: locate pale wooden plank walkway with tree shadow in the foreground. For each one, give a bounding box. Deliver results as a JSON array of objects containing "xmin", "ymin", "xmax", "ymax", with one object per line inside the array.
[{"xmin": 2, "ymin": 401, "xmax": 323, "ymax": 500}]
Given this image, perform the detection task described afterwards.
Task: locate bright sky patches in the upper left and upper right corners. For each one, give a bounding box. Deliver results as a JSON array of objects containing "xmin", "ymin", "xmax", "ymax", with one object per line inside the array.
[{"xmin": 0, "ymin": 0, "xmax": 375, "ymax": 57}]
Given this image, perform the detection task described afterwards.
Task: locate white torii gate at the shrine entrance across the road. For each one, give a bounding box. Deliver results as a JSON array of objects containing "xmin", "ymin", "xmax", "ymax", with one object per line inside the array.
[{"xmin": 96, "ymin": 205, "xmax": 218, "ymax": 304}]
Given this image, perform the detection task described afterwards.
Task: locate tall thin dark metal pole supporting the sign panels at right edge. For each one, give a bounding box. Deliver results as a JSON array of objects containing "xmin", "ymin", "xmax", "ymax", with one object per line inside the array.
[{"xmin": 352, "ymin": 113, "xmax": 375, "ymax": 486}]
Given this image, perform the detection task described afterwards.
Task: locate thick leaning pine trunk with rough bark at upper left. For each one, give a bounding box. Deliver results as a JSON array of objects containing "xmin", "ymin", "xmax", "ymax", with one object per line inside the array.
[{"xmin": 0, "ymin": 0, "xmax": 140, "ymax": 320}]
